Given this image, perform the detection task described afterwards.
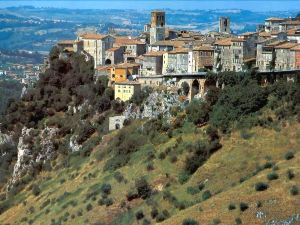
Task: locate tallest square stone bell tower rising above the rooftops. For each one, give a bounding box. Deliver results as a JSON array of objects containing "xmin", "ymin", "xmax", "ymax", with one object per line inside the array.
[{"xmin": 150, "ymin": 10, "xmax": 166, "ymax": 44}]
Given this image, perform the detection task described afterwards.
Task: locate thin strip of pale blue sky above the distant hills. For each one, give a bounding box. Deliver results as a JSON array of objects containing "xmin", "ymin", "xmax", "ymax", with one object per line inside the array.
[{"xmin": 0, "ymin": 0, "xmax": 300, "ymax": 11}]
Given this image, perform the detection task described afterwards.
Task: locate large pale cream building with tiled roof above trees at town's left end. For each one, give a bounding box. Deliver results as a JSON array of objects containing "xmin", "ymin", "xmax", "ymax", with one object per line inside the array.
[{"xmin": 78, "ymin": 33, "xmax": 115, "ymax": 68}]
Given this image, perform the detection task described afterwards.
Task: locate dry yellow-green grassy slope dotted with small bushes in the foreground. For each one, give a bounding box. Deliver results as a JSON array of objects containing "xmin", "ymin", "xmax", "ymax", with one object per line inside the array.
[{"xmin": 0, "ymin": 120, "xmax": 300, "ymax": 224}]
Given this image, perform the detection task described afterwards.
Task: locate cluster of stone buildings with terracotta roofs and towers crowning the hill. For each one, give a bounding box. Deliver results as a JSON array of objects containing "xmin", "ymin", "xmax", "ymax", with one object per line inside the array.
[{"xmin": 57, "ymin": 10, "xmax": 300, "ymax": 101}]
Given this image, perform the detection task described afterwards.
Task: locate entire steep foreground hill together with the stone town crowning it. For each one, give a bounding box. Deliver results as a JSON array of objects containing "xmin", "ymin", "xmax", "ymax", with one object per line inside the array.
[{"xmin": 0, "ymin": 10, "xmax": 300, "ymax": 225}]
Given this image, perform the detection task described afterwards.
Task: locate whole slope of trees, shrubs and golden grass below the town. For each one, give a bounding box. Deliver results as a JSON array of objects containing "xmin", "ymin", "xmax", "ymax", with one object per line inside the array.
[{"xmin": 0, "ymin": 48, "xmax": 300, "ymax": 225}]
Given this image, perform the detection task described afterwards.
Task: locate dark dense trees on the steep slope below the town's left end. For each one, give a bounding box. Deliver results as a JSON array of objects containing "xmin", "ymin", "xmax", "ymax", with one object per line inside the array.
[{"xmin": 2, "ymin": 47, "xmax": 113, "ymax": 136}]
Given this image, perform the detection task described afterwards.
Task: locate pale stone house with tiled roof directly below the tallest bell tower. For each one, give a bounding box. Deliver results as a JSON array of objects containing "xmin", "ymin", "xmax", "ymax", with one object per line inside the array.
[{"xmin": 140, "ymin": 51, "xmax": 165, "ymax": 76}]
